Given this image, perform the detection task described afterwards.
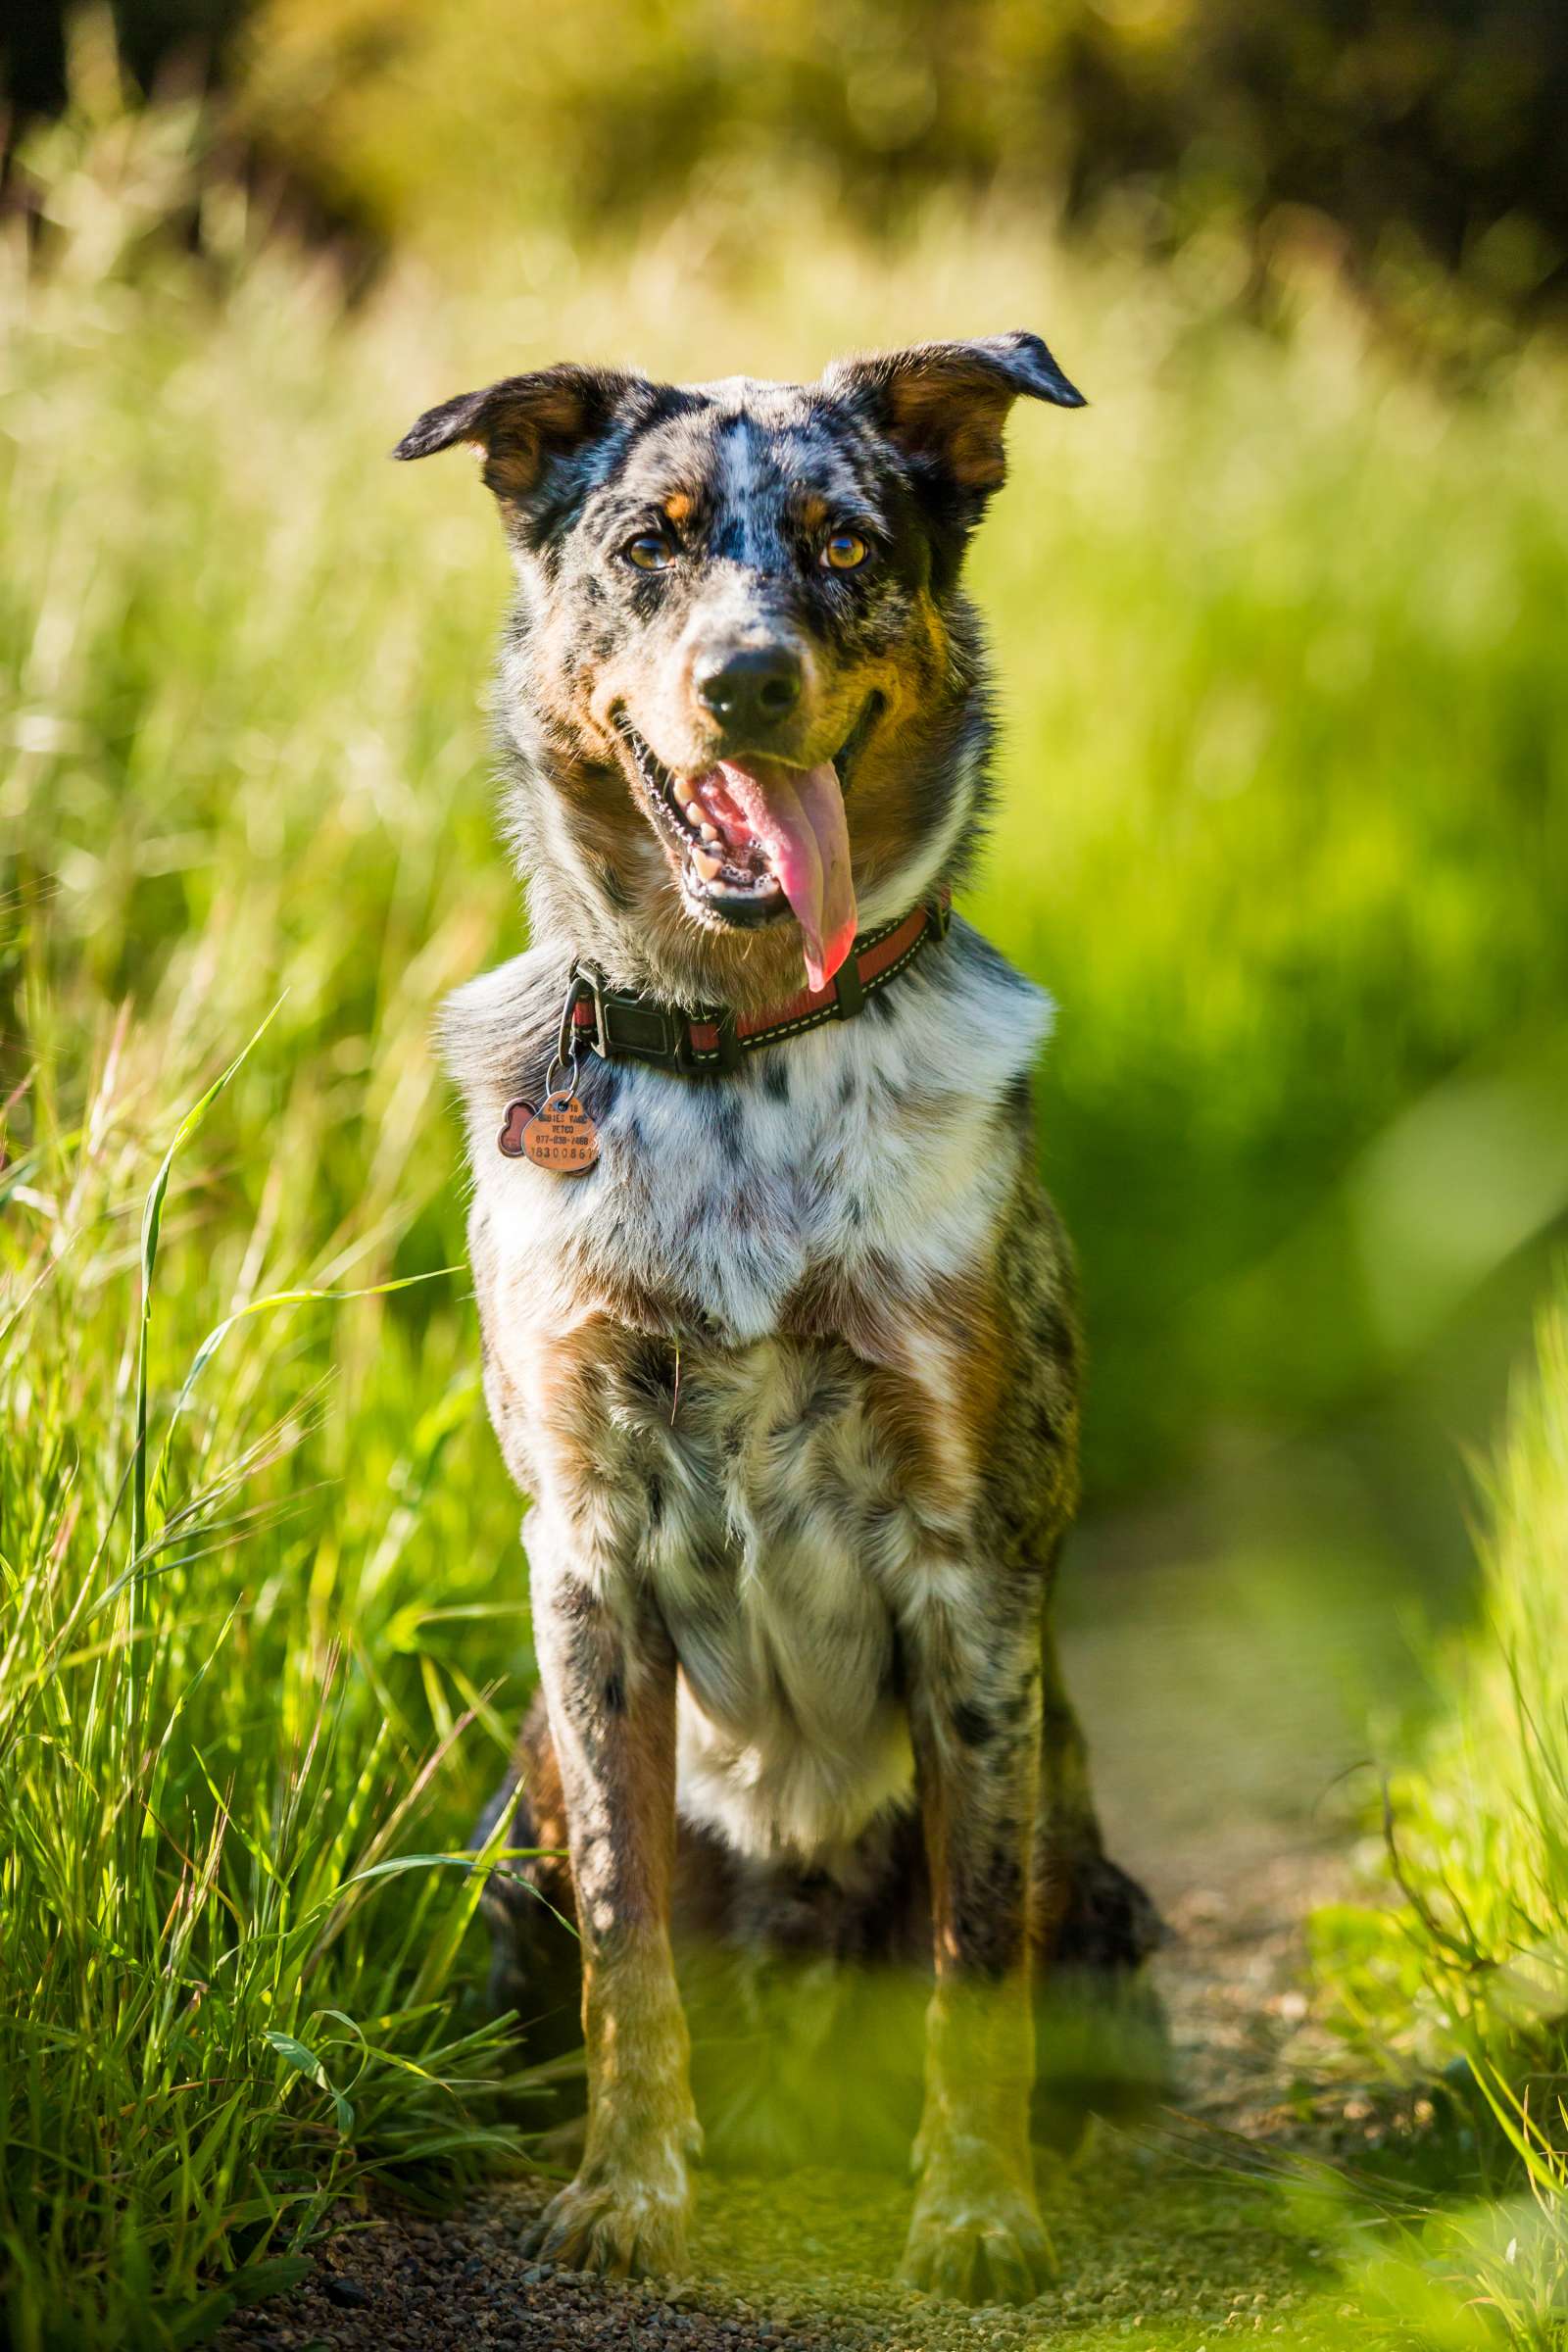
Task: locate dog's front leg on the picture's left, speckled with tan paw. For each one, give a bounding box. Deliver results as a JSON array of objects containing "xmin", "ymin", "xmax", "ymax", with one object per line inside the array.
[{"xmin": 529, "ymin": 1527, "xmax": 701, "ymax": 2277}]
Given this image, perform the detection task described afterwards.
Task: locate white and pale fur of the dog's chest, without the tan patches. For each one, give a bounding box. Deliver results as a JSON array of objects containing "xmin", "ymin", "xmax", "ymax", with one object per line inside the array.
[{"xmin": 452, "ymin": 927, "xmax": 1049, "ymax": 1858}]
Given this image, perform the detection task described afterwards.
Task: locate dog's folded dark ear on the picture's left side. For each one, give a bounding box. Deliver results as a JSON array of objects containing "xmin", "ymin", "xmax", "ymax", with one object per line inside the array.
[{"xmin": 393, "ymin": 363, "xmax": 651, "ymax": 522}]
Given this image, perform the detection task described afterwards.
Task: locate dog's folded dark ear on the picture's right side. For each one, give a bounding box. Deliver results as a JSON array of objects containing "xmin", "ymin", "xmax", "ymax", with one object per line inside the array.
[{"xmin": 823, "ymin": 331, "xmax": 1086, "ymax": 501}]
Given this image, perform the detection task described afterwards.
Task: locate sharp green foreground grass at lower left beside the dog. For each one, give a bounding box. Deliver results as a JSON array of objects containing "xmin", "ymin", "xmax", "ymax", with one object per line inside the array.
[{"xmin": 0, "ymin": 997, "xmax": 533, "ymax": 2347}]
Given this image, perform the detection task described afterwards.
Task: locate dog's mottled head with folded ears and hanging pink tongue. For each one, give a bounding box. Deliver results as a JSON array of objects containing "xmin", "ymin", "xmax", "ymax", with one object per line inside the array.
[{"xmin": 395, "ymin": 334, "xmax": 1081, "ymax": 986}]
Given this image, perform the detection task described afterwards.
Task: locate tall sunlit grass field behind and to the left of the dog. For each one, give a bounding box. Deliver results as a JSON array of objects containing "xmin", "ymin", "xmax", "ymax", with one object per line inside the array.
[{"xmin": 0, "ymin": 64, "xmax": 1568, "ymax": 2345}]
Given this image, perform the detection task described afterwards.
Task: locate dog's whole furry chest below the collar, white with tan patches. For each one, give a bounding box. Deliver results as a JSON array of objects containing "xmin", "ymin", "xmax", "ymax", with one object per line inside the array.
[{"xmin": 449, "ymin": 924, "xmax": 1049, "ymax": 1858}]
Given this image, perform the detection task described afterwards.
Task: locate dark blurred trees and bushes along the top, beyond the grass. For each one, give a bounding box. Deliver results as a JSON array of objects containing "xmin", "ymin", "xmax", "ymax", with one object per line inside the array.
[{"xmin": 0, "ymin": 0, "xmax": 1568, "ymax": 336}]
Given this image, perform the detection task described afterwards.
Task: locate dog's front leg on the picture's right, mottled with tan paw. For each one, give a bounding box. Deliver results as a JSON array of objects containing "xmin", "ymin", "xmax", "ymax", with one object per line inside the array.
[{"xmin": 903, "ymin": 1608, "xmax": 1055, "ymax": 2303}]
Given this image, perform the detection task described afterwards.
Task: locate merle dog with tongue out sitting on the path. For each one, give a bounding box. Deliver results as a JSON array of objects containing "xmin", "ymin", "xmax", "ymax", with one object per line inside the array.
[{"xmin": 395, "ymin": 334, "xmax": 1159, "ymax": 2300}]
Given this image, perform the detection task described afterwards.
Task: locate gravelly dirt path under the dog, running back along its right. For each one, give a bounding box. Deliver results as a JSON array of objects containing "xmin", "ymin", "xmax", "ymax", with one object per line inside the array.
[{"xmin": 220, "ymin": 1527, "xmax": 1392, "ymax": 2352}]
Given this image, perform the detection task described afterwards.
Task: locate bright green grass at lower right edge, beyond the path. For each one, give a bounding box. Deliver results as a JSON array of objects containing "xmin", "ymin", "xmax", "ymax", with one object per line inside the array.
[{"xmin": 1316, "ymin": 1277, "xmax": 1568, "ymax": 2352}]
